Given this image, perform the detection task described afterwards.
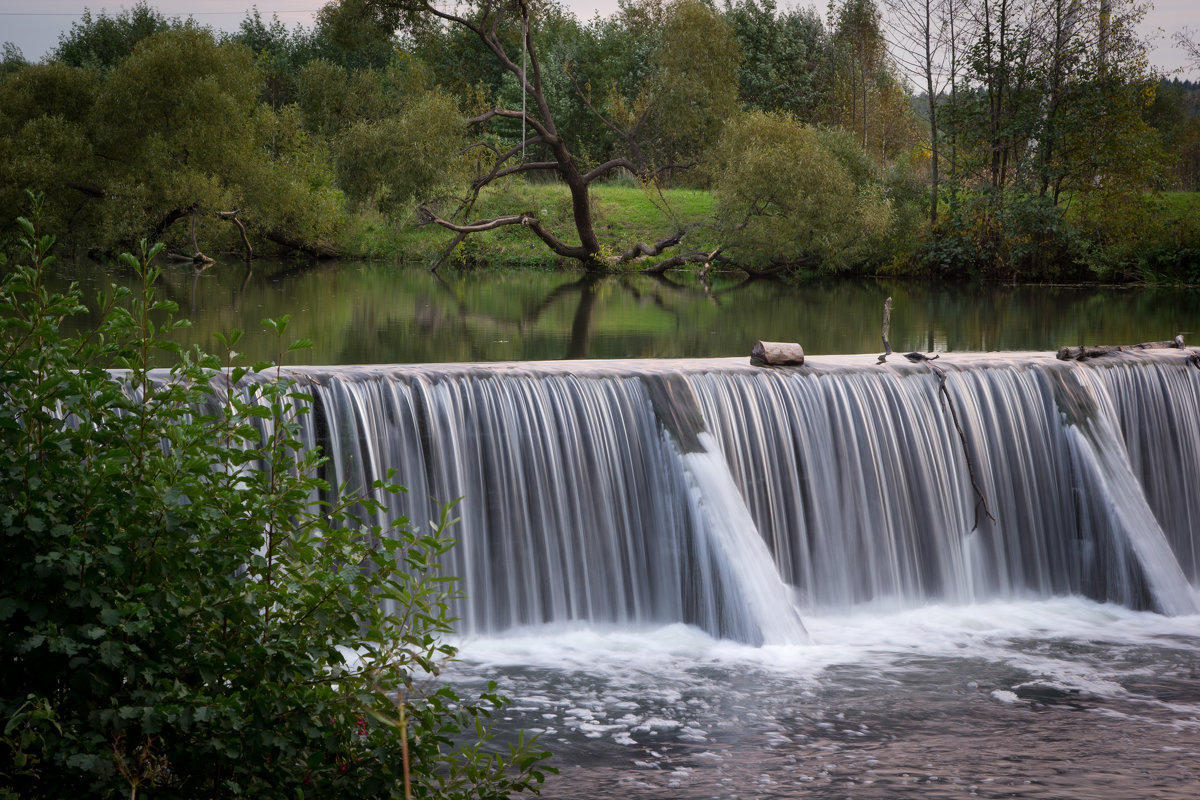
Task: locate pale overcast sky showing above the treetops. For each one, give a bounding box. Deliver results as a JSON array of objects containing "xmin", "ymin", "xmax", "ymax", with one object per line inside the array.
[{"xmin": 0, "ymin": 0, "xmax": 1200, "ymax": 78}]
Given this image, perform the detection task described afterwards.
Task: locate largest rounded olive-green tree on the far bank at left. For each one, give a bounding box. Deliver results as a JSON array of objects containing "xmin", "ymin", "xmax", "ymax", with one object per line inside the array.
[{"xmin": 70, "ymin": 25, "xmax": 340, "ymax": 254}]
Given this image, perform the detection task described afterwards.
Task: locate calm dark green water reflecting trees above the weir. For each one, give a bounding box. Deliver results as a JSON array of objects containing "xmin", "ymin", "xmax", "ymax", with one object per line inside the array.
[{"xmin": 49, "ymin": 260, "xmax": 1200, "ymax": 365}]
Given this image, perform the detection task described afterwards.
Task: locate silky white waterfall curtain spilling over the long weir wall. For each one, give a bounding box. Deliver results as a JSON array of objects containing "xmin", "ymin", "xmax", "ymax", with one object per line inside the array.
[{"xmin": 283, "ymin": 353, "xmax": 1200, "ymax": 643}]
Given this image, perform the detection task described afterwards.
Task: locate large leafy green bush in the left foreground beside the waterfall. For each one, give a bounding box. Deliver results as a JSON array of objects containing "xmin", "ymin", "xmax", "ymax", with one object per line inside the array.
[{"xmin": 0, "ymin": 195, "xmax": 547, "ymax": 799}]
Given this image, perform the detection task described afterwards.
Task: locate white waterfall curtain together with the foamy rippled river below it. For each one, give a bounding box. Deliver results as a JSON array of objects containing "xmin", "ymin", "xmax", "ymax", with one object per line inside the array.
[{"xmin": 265, "ymin": 353, "xmax": 1200, "ymax": 800}]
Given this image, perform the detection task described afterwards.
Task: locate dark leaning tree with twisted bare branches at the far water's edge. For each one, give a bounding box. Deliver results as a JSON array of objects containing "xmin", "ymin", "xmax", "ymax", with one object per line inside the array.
[{"xmin": 348, "ymin": 0, "xmax": 736, "ymax": 271}]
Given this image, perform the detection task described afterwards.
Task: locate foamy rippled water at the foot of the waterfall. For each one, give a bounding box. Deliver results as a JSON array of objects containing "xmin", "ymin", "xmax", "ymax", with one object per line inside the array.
[{"xmin": 451, "ymin": 599, "xmax": 1200, "ymax": 800}]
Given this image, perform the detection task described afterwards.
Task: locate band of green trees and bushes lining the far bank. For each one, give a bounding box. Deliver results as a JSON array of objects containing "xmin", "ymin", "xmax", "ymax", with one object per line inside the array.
[{"xmin": 0, "ymin": 0, "xmax": 1200, "ymax": 282}]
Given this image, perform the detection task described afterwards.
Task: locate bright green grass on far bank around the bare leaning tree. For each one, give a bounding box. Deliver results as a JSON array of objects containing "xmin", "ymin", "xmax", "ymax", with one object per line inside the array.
[{"xmin": 343, "ymin": 181, "xmax": 715, "ymax": 267}]
